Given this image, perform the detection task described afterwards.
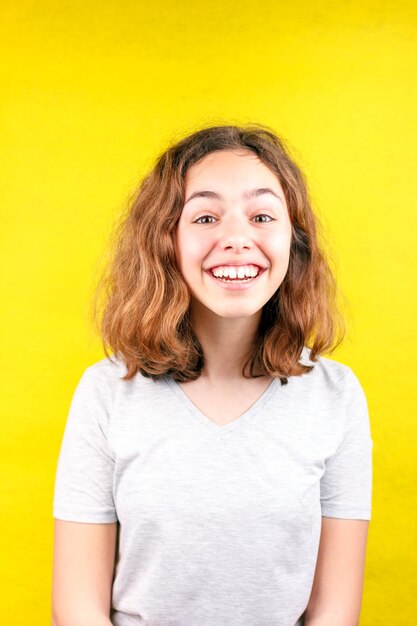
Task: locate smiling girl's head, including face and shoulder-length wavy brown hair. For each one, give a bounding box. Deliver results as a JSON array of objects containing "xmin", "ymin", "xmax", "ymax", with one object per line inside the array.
[{"xmin": 93, "ymin": 125, "xmax": 343, "ymax": 382}]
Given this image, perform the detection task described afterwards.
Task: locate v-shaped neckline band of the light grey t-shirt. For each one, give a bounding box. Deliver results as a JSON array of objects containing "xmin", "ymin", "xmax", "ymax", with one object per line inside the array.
[{"xmin": 165, "ymin": 375, "xmax": 281, "ymax": 434}]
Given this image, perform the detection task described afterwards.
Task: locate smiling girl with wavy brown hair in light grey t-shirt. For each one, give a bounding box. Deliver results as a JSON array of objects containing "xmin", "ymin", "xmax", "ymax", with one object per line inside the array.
[{"xmin": 52, "ymin": 125, "xmax": 372, "ymax": 626}]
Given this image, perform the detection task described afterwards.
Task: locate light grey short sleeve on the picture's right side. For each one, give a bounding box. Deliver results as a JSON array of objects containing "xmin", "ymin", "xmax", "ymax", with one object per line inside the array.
[{"xmin": 320, "ymin": 368, "xmax": 373, "ymax": 520}]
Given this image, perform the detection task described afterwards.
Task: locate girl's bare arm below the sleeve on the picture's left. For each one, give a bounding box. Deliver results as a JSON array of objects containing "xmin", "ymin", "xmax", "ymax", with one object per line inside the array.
[{"xmin": 52, "ymin": 519, "xmax": 117, "ymax": 626}]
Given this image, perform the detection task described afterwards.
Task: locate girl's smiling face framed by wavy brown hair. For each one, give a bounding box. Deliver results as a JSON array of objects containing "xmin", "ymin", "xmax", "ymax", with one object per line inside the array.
[{"xmin": 175, "ymin": 150, "xmax": 291, "ymax": 318}]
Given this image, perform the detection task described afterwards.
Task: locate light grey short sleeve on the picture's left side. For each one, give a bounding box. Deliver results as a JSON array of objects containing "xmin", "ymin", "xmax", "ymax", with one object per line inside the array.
[{"xmin": 53, "ymin": 366, "xmax": 117, "ymax": 523}]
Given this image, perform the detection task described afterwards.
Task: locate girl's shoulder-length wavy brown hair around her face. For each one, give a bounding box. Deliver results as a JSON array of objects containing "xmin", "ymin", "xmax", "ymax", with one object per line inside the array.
[{"xmin": 91, "ymin": 124, "xmax": 345, "ymax": 384}]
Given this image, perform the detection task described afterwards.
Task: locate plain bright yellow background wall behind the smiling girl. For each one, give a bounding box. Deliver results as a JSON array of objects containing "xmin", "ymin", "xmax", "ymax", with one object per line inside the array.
[{"xmin": 0, "ymin": 0, "xmax": 417, "ymax": 626}]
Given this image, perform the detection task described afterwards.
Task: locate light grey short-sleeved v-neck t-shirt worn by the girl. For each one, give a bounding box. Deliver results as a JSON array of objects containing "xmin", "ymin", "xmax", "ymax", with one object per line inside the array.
[{"xmin": 53, "ymin": 348, "xmax": 373, "ymax": 626}]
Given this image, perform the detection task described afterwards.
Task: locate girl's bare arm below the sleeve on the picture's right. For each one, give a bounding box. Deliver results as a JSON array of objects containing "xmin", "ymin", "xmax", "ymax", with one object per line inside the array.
[{"xmin": 305, "ymin": 517, "xmax": 369, "ymax": 626}]
